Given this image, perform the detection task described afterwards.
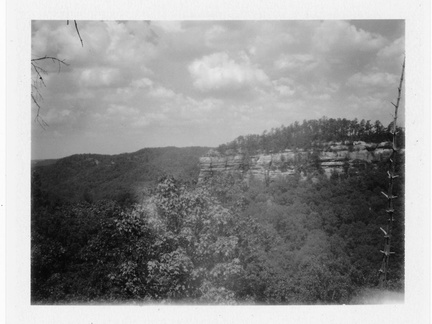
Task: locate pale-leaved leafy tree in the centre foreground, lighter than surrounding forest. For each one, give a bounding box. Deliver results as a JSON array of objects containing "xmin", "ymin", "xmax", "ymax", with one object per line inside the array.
[{"xmin": 150, "ymin": 177, "xmax": 242, "ymax": 303}]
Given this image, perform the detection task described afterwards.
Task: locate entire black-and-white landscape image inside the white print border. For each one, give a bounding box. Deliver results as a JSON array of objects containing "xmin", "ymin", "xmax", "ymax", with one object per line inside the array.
[{"xmin": 29, "ymin": 20, "xmax": 405, "ymax": 305}]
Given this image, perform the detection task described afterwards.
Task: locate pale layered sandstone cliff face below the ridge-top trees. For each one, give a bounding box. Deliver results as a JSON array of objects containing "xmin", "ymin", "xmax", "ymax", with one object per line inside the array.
[{"xmin": 199, "ymin": 141, "xmax": 392, "ymax": 181}]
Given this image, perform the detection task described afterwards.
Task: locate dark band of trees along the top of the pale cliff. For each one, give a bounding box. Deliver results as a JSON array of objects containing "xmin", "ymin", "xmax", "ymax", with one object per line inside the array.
[{"xmin": 218, "ymin": 117, "xmax": 404, "ymax": 154}]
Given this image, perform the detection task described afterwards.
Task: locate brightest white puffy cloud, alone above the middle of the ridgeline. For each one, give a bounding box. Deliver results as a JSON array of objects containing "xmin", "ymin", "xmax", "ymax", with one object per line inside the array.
[{"xmin": 188, "ymin": 52, "xmax": 269, "ymax": 91}]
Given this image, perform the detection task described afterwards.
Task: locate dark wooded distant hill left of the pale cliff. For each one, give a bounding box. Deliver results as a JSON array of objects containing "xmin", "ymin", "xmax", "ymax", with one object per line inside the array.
[{"xmin": 32, "ymin": 147, "xmax": 210, "ymax": 202}]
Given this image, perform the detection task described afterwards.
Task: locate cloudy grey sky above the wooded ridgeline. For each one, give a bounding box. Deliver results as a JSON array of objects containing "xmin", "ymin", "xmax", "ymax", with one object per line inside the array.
[{"xmin": 31, "ymin": 20, "xmax": 405, "ymax": 159}]
